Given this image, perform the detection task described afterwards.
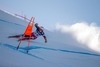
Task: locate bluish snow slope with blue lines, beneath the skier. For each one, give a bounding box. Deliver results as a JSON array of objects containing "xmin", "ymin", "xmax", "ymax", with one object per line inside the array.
[{"xmin": 0, "ymin": 10, "xmax": 100, "ymax": 67}]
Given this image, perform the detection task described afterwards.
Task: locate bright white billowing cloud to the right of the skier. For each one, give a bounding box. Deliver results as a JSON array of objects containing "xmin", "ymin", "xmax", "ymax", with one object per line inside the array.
[{"xmin": 56, "ymin": 22, "xmax": 100, "ymax": 52}]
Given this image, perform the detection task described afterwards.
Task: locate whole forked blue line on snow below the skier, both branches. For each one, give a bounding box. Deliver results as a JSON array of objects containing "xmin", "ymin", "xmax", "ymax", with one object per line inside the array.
[{"xmin": 0, "ymin": 44, "xmax": 100, "ymax": 57}]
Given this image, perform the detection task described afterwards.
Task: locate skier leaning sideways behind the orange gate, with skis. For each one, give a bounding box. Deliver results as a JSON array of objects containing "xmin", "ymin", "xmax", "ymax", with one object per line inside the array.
[{"xmin": 8, "ymin": 23, "xmax": 47, "ymax": 43}]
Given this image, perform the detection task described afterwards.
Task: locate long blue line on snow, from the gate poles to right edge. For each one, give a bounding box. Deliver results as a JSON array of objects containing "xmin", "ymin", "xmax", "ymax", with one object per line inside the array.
[{"xmin": 20, "ymin": 46, "xmax": 100, "ymax": 57}]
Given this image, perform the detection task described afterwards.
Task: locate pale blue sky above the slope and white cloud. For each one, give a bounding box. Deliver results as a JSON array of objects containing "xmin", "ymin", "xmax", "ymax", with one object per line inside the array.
[{"xmin": 0, "ymin": 0, "xmax": 100, "ymax": 30}]
